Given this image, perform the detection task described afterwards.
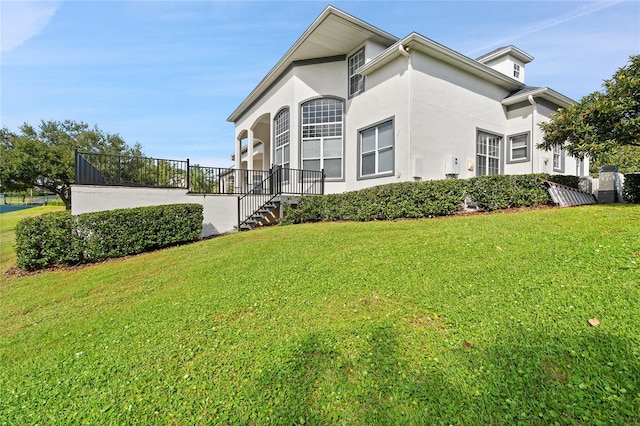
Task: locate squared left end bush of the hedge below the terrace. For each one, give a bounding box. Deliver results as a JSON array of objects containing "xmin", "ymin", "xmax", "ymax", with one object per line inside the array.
[{"xmin": 16, "ymin": 211, "xmax": 83, "ymax": 271}]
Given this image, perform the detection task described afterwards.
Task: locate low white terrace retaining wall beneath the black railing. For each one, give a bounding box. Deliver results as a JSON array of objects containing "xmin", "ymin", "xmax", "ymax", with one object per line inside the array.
[{"xmin": 71, "ymin": 185, "xmax": 238, "ymax": 237}]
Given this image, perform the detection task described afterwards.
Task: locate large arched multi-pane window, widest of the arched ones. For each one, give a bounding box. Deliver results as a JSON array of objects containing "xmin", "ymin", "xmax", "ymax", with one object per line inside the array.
[{"xmin": 301, "ymin": 98, "xmax": 343, "ymax": 179}]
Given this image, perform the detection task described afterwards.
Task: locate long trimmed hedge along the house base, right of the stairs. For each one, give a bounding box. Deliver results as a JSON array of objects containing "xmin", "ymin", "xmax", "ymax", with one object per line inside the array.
[{"xmin": 281, "ymin": 174, "xmax": 579, "ymax": 224}]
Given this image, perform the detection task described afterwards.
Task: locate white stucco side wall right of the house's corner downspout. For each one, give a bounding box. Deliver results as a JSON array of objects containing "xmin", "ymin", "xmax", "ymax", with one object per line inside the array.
[{"xmin": 411, "ymin": 52, "xmax": 508, "ymax": 180}]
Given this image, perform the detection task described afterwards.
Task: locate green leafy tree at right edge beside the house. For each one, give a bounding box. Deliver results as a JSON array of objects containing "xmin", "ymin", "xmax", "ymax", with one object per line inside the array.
[{"xmin": 538, "ymin": 55, "xmax": 640, "ymax": 168}]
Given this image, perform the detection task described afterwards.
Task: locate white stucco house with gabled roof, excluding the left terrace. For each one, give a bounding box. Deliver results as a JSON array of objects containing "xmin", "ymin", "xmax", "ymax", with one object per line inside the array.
[{"xmin": 228, "ymin": 6, "xmax": 588, "ymax": 193}]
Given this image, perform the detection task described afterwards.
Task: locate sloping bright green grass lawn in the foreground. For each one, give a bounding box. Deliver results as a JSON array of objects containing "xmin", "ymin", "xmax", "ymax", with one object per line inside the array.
[{"xmin": 0, "ymin": 205, "xmax": 640, "ymax": 425}]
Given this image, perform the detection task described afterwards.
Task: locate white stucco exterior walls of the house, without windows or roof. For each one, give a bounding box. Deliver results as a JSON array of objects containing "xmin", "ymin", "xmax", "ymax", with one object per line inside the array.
[{"xmin": 229, "ymin": 43, "xmax": 588, "ymax": 193}]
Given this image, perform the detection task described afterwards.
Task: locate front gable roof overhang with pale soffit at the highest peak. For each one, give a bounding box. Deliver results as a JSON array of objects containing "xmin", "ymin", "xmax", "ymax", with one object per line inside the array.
[{"xmin": 227, "ymin": 6, "xmax": 398, "ymax": 122}]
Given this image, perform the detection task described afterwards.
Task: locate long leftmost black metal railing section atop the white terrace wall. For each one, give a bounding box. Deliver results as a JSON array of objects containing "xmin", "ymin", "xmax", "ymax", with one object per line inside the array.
[{"xmin": 75, "ymin": 151, "xmax": 189, "ymax": 189}]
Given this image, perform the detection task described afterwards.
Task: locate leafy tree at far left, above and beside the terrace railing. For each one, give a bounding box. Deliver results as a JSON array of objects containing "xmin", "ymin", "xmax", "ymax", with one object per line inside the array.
[{"xmin": 0, "ymin": 120, "xmax": 142, "ymax": 210}]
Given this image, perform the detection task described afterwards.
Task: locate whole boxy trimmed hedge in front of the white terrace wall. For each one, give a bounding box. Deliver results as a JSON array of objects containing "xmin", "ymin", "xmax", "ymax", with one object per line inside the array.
[{"xmin": 16, "ymin": 204, "xmax": 203, "ymax": 271}]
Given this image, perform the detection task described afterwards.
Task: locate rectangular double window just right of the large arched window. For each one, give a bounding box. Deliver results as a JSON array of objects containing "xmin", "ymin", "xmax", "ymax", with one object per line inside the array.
[{"xmin": 358, "ymin": 120, "xmax": 394, "ymax": 178}]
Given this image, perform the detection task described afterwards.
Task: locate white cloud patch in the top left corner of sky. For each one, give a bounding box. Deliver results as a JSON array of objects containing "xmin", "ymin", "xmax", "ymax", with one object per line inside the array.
[{"xmin": 0, "ymin": 1, "xmax": 60, "ymax": 52}]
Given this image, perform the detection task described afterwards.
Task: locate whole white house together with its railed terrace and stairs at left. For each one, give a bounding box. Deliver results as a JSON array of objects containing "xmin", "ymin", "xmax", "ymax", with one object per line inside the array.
[{"xmin": 72, "ymin": 6, "xmax": 589, "ymax": 236}]
